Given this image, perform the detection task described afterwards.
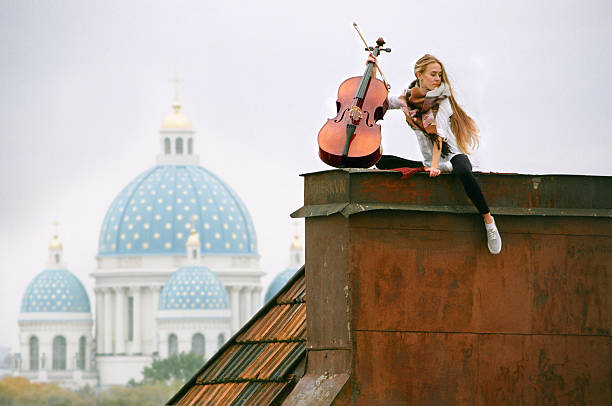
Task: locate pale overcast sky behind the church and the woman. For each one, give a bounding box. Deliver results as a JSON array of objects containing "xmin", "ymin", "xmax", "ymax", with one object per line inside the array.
[{"xmin": 0, "ymin": 0, "xmax": 612, "ymax": 351}]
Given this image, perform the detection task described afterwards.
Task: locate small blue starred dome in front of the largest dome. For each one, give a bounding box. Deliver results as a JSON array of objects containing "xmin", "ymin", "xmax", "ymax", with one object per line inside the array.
[{"xmin": 159, "ymin": 266, "xmax": 229, "ymax": 310}]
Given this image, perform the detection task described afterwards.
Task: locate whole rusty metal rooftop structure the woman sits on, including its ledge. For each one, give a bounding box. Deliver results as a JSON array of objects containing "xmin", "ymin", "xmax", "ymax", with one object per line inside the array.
[{"xmin": 301, "ymin": 171, "xmax": 612, "ymax": 405}]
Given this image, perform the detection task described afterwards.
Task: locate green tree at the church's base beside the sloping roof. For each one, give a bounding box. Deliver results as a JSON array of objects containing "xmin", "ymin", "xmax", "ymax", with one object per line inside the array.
[{"xmin": 142, "ymin": 352, "xmax": 205, "ymax": 383}]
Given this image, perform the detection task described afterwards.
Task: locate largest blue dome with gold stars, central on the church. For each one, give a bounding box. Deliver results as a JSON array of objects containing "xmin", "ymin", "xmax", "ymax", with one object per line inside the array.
[{"xmin": 98, "ymin": 165, "xmax": 257, "ymax": 256}]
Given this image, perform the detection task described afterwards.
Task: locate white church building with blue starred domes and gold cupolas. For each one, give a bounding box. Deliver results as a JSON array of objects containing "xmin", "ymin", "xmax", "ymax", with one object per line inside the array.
[{"xmin": 18, "ymin": 94, "xmax": 303, "ymax": 387}]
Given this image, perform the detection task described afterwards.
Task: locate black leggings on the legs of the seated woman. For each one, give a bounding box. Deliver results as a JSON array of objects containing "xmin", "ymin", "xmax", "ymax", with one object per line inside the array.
[{"xmin": 376, "ymin": 154, "xmax": 489, "ymax": 214}]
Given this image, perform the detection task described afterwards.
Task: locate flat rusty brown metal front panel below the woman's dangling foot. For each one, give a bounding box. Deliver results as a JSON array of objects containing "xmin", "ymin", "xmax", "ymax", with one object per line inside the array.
[{"xmin": 340, "ymin": 211, "xmax": 612, "ymax": 405}]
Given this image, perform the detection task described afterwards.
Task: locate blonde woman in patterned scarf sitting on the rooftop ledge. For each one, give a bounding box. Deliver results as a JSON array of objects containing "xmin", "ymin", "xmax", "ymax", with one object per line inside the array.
[{"xmin": 369, "ymin": 54, "xmax": 502, "ymax": 254}]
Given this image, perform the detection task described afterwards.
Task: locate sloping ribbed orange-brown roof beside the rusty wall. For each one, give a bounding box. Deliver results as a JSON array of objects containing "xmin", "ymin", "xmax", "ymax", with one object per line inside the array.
[{"xmin": 167, "ymin": 267, "xmax": 306, "ymax": 406}]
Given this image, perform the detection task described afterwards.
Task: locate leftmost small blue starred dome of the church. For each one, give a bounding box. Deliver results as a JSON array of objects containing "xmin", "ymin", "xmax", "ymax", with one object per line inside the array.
[{"xmin": 21, "ymin": 269, "xmax": 90, "ymax": 313}]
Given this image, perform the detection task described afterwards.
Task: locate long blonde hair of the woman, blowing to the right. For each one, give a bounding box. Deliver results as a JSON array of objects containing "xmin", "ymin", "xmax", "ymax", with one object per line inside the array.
[{"xmin": 414, "ymin": 54, "xmax": 480, "ymax": 154}]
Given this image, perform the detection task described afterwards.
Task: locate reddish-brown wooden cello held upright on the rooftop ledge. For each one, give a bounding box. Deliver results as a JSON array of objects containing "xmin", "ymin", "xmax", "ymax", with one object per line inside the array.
[{"xmin": 317, "ymin": 23, "xmax": 391, "ymax": 168}]
